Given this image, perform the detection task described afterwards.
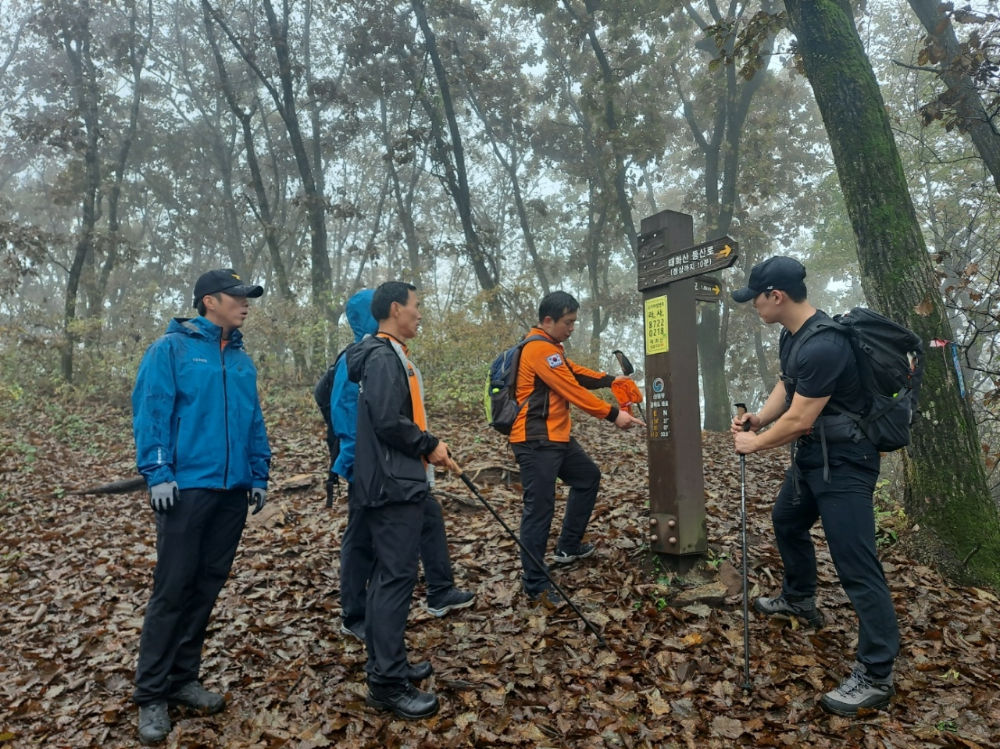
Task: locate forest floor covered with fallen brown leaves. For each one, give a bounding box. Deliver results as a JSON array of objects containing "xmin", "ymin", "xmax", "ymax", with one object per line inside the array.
[{"xmin": 0, "ymin": 396, "xmax": 1000, "ymax": 749}]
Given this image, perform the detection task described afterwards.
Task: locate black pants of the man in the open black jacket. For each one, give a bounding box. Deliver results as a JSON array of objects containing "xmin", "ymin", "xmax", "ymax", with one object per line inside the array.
[{"xmin": 362, "ymin": 500, "xmax": 428, "ymax": 685}]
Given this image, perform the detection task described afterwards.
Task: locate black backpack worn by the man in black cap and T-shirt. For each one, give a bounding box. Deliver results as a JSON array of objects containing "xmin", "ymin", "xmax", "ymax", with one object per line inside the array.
[{"xmin": 782, "ymin": 307, "xmax": 924, "ymax": 452}]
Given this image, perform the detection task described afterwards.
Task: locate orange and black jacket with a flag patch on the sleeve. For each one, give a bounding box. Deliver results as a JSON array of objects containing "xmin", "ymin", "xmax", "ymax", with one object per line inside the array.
[{"xmin": 510, "ymin": 328, "xmax": 618, "ymax": 443}]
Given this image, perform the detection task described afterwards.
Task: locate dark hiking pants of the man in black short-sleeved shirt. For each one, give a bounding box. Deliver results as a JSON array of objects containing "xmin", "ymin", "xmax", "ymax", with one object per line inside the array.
[{"xmin": 771, "ymin": 440, "xmax": 899, "ymax": 679}]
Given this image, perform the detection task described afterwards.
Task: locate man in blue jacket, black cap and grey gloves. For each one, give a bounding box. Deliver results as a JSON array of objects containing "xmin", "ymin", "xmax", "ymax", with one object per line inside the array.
[{"xmin": 132, "ymin": 269, "xmax": 271, "ymax": 745}]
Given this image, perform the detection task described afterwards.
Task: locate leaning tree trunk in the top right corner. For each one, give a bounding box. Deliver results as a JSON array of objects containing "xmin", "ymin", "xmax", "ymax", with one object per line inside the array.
[{"xmin": 909, "ymin": 0, "xmax": 1000, "ymax": 196}]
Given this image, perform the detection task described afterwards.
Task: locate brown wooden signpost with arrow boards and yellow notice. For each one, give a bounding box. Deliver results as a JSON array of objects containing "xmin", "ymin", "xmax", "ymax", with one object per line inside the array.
[{"xmin": 639, "ymin": 211, "xmax": 739, "ymax": 568}]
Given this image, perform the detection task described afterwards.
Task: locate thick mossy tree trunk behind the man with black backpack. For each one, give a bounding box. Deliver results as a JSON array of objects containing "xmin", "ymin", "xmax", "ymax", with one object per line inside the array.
[{"xmin": 785, "ymin": 0, "xmax": 1000, "ymax": 586}]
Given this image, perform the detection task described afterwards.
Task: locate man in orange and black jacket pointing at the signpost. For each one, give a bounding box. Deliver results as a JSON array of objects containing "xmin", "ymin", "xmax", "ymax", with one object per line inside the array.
[{"xmin": 510, "ymin": 291, "xmax": 645, "ymax": 604}]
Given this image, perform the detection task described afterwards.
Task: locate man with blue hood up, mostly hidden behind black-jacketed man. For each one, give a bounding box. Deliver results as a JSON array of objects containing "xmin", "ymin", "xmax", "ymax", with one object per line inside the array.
[{"xmin": 330, "ymin": 289, "xmax": 476, "ymax": 640}]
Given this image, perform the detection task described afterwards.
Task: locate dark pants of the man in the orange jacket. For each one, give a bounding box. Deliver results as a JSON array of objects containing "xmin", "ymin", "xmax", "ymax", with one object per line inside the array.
[{"xmin": 512, "ymin": 438, "xmax": 601, "ymax": 595}]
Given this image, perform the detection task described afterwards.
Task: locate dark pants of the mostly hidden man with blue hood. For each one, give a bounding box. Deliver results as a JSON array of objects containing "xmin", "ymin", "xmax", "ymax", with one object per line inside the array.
[{"xmin": 340, "ymin": 484, "xmax": 455, "ymax": 627}]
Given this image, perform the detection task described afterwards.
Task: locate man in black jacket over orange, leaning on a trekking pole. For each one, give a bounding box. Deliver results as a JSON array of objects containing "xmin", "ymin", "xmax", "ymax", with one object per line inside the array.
[{"xmin": 347, "ymin": 281, "xmax": 453, "ymax": 720}]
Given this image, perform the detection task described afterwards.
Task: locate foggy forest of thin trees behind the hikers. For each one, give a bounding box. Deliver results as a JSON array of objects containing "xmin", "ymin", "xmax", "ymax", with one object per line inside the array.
[{"xmin": 0, "ymin": 0, "xmax": 1000, "ymax": 496}]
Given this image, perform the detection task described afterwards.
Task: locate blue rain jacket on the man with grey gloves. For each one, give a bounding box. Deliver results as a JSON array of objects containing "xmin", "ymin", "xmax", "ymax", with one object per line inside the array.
[{"xmin": 132, "ymin": 317, "xmax": 271, "ymax": 490}]
